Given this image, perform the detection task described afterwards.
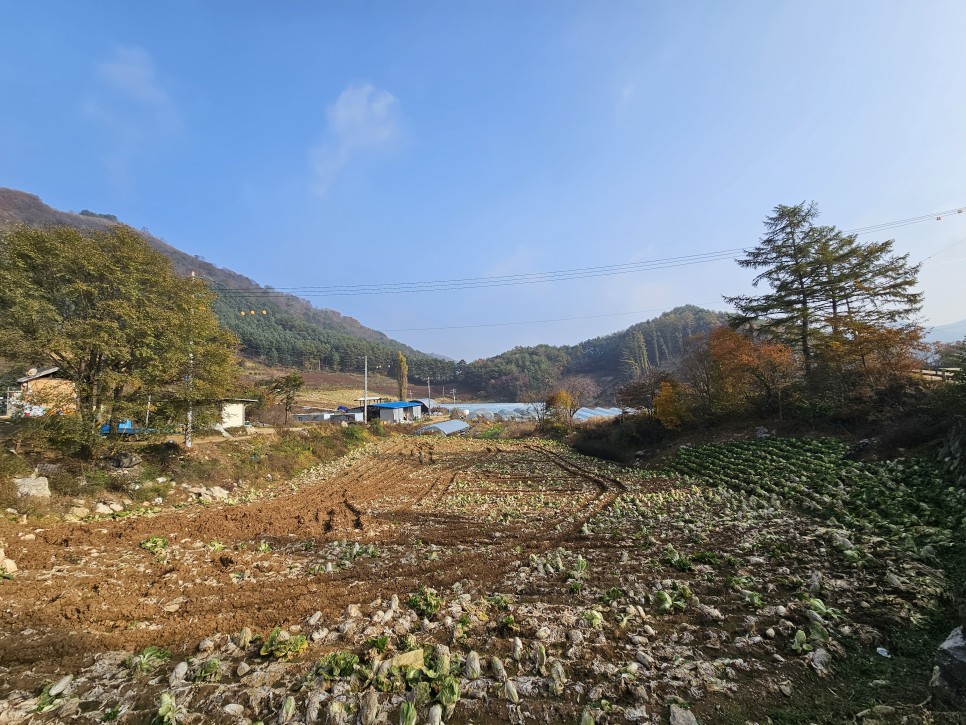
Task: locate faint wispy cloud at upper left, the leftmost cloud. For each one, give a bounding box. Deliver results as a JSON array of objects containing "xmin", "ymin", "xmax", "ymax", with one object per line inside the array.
[{"xmin": 80, "ymin": 46, "xmax": 182, "ymax": 182}]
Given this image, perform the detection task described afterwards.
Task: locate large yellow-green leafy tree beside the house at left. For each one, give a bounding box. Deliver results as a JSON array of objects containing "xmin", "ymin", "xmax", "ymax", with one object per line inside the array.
[{"xmin": 0, "ymin": 226, "xmax": 236, "ymax": 455}]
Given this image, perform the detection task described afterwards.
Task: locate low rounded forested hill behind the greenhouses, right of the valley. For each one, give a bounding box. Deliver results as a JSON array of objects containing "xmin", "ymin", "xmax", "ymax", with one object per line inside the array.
[{"xmin": 460, "ymin": 305, "xmax": 727, "ymax": 402}]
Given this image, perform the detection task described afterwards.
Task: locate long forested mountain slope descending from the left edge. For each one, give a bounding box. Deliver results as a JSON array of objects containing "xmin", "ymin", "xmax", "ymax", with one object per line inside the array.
[{"xmin": 0, "ymin": 187, "xmax": 454, "ymax": 380}]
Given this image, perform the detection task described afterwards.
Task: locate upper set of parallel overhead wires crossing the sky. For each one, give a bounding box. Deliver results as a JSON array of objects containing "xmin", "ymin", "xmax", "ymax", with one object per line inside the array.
[{"xmin": 215, "ymin": 202, "xmax": 966, "ymax": 298}]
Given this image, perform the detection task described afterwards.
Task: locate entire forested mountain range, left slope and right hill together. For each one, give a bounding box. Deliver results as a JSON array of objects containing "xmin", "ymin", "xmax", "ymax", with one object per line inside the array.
[{"xmin": 0, "ymin": 188, "xmax": 725, "ymax": 402}]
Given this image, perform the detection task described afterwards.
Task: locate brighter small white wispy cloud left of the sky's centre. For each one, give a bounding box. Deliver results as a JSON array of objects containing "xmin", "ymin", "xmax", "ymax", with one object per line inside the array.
[{"xmin": 311, "ymin": 83, "xmax": 400, "ymax": 196}]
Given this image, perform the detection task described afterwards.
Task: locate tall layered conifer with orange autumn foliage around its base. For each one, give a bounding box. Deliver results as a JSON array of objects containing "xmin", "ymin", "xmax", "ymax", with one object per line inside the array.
[{"xmin": 725, "ymin": 202, "xmax": 922, "ymax": 414}]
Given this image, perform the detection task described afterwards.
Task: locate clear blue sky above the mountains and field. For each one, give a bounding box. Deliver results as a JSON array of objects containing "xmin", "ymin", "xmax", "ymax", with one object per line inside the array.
[{"xmin": 0, "ymin": 0, "xmax": 966, "ymax": 360}]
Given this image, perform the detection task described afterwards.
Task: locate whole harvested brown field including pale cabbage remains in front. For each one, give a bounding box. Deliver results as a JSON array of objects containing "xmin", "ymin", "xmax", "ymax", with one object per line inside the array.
[{"xmin": 0, "ymin": 438, "xmax": 956, "ymax": 723}]
